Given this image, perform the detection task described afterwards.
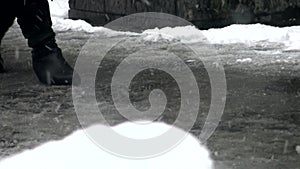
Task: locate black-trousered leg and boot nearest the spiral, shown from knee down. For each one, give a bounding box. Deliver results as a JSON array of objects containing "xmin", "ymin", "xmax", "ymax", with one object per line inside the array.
[{"xmin": 17, "ymin": 0, "xmax": 78, "ymax": 85}]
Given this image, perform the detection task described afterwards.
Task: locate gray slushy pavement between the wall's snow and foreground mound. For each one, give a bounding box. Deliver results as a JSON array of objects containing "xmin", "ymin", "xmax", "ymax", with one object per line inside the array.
[{"xmin": 0, "ymin": 22, "xmax": 300, "ymax": 169}]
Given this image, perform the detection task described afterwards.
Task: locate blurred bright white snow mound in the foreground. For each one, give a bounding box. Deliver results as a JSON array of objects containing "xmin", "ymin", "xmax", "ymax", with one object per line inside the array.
[{"xmin": 0, "ymin": 122, "xmax": 213, "ymax": 169}]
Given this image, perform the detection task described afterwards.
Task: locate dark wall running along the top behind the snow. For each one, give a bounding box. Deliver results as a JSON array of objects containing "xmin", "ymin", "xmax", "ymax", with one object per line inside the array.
[{"xmin": 69, "ymin": 0, "xmax": 300, "ymax": 29}]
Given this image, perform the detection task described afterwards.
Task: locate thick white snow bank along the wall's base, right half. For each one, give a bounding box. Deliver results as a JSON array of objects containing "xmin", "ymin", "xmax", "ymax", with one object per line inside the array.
[{"xmin": 144, "ymin": 24, "xmax": 300, "ymax": 50}]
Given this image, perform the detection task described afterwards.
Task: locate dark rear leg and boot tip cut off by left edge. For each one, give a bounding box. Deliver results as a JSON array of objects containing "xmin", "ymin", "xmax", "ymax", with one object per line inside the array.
[{"xmin": 0, "ymin": 3, "xmax": 15, "ymax": 73}]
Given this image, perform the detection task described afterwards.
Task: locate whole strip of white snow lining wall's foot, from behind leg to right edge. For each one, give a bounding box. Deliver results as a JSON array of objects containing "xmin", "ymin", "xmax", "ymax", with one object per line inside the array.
[{"xmin": 49, "ymin": 0, "xmax": 300, "ymax": 50}]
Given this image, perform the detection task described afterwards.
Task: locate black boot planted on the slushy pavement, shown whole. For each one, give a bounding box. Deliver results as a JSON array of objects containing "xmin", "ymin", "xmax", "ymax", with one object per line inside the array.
[{"xmin": 32, "ymin": 40, "xmax": 80, "ymax": 85}]
